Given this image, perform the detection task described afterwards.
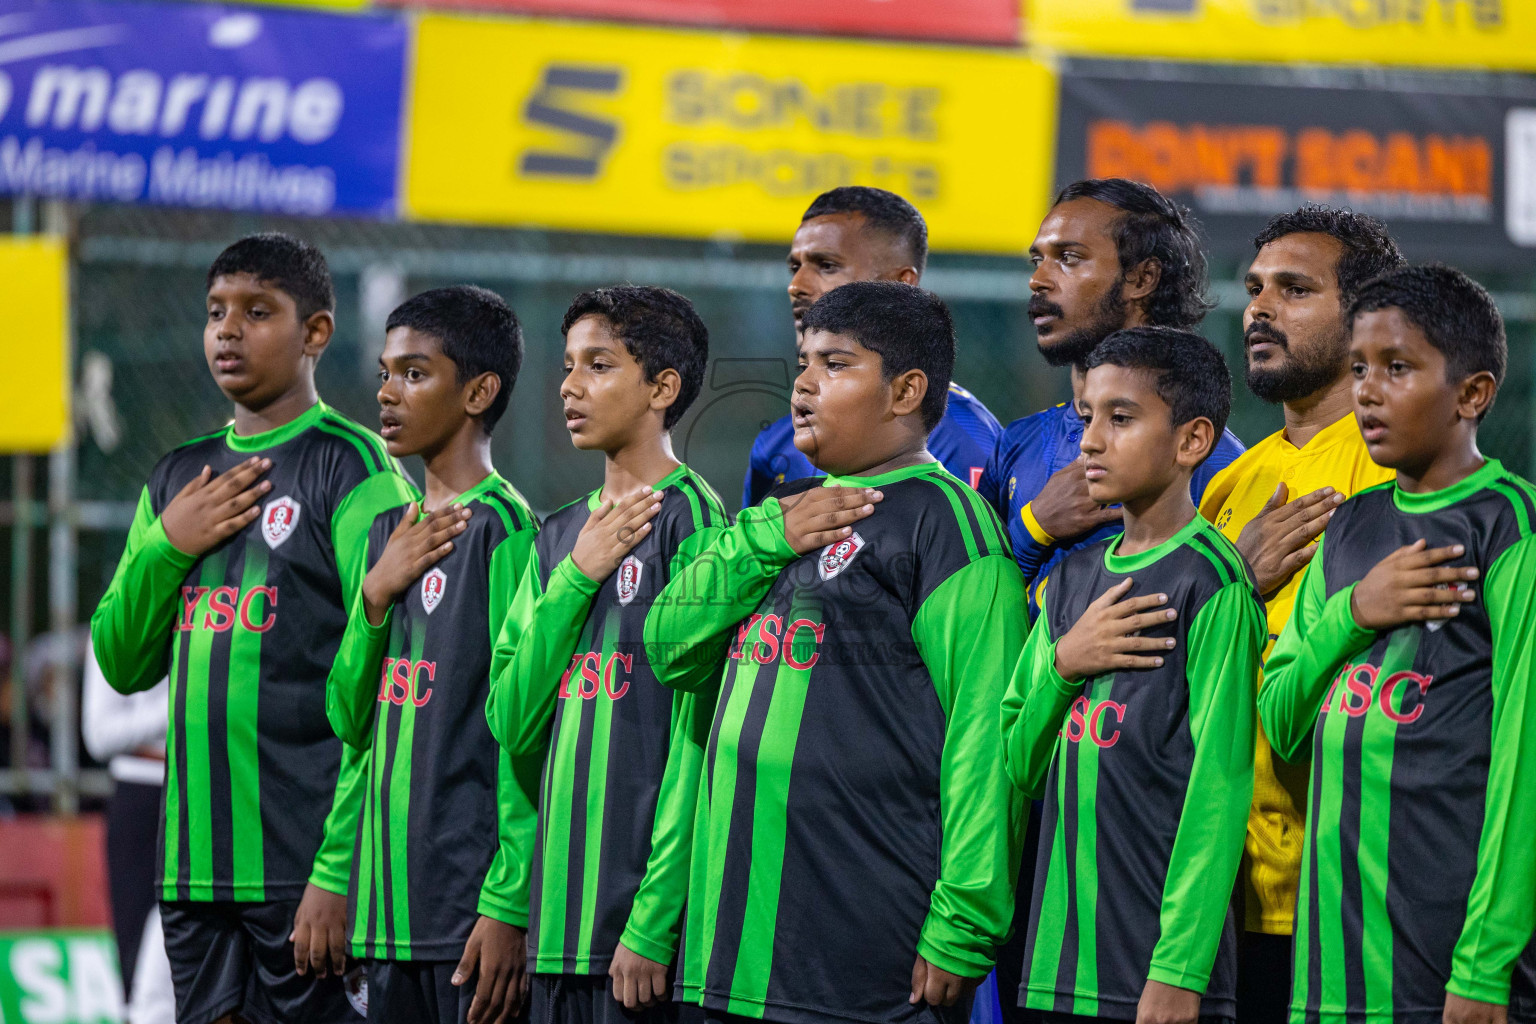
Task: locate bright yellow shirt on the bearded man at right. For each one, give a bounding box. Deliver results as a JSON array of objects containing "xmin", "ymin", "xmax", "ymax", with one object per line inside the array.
[{"xmin": 1200, "ymin": 415, "xmax": 1393, "ymax": 935}]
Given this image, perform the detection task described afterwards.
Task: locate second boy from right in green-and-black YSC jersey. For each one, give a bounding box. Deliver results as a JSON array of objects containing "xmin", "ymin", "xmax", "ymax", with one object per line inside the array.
[{"xmin": 1001, "ymin": 327, "xmax": 1264, "ymax": 1024}]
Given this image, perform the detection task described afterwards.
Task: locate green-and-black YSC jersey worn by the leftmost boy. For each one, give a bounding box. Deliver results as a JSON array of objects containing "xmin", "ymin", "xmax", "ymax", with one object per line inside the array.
[{"xmin": 91, "ymin": 404, "xmax": 415, "ymax": 900}]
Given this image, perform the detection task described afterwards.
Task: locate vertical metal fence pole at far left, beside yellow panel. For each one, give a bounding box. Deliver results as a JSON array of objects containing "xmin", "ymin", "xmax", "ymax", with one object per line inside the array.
[{"xmin": 43, "ymin": 200, "xmax": 81, "ymax": 814}]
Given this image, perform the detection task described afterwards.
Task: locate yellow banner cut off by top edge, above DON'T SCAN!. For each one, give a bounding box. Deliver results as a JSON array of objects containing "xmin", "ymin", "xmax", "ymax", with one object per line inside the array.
[{"xmin": 1026, "ymin": 0, "xmax": 1536, "ymax": 71}]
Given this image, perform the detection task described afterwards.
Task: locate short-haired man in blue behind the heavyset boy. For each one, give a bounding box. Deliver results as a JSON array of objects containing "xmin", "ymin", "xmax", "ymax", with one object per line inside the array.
[{"xmin": 742, "ymin": 186, "xmax": 1003, "ymax": 508}]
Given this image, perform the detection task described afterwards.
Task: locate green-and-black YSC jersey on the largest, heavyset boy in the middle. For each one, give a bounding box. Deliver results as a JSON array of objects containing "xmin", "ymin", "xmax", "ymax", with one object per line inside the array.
[{"xmin": 645, "ymin": 462, "xmax": 1029, "ymax": 1024}]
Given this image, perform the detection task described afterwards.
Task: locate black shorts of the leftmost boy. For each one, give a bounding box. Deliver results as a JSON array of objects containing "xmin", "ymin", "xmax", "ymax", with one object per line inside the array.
[{"xmin": 160, "ymin": 900, "xmax": 362, "ymax": 1024}]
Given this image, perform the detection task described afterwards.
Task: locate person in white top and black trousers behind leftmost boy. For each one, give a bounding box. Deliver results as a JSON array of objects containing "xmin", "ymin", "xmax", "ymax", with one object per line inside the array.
[{"xmin": 80, "ymin": 645, "xmax": 175, "ymax": 1024}]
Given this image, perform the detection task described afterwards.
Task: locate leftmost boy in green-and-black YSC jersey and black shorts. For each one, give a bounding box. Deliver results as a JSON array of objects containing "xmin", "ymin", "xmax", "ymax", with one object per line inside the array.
[{"xmin": 91, "ymin": 235, "xmax": 415, "ymax": 1024}]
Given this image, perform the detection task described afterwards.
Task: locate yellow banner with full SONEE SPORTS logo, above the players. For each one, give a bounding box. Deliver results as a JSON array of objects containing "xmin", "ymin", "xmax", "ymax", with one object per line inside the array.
[{"xmin": 406, "ymin": 15, "xmax": 1055, "ymax": 252}]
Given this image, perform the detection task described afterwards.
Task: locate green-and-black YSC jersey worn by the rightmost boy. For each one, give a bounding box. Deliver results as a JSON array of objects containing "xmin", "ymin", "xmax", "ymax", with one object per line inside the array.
[{"xmin": 1260, "ymin": 459, "xmax": 1536, "ymax": 1024}]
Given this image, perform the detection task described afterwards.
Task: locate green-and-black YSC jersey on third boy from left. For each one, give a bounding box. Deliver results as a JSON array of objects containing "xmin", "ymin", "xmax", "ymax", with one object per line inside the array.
[{"xmin": 487, "ymin": 465, "xmax": 727, "ymax": 975}]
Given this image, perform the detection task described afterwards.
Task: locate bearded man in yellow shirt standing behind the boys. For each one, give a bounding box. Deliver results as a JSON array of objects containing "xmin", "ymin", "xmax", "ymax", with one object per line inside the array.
[{"xmin": 1200, "ymin": 206, "xmax": 1404, "ymax": 1024}]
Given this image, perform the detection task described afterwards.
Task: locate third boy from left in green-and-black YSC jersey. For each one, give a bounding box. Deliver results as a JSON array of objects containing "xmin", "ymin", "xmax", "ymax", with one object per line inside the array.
[{"xmin": 487, "ymin": 287, "xmax": 725, "ymax": 1024}]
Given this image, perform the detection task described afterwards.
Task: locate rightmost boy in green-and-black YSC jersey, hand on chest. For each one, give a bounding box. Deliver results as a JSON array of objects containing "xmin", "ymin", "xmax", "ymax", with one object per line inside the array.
[{"xmin": 1260, "ymin": 266, "xmax": 1536, "ymax": 1024}]
